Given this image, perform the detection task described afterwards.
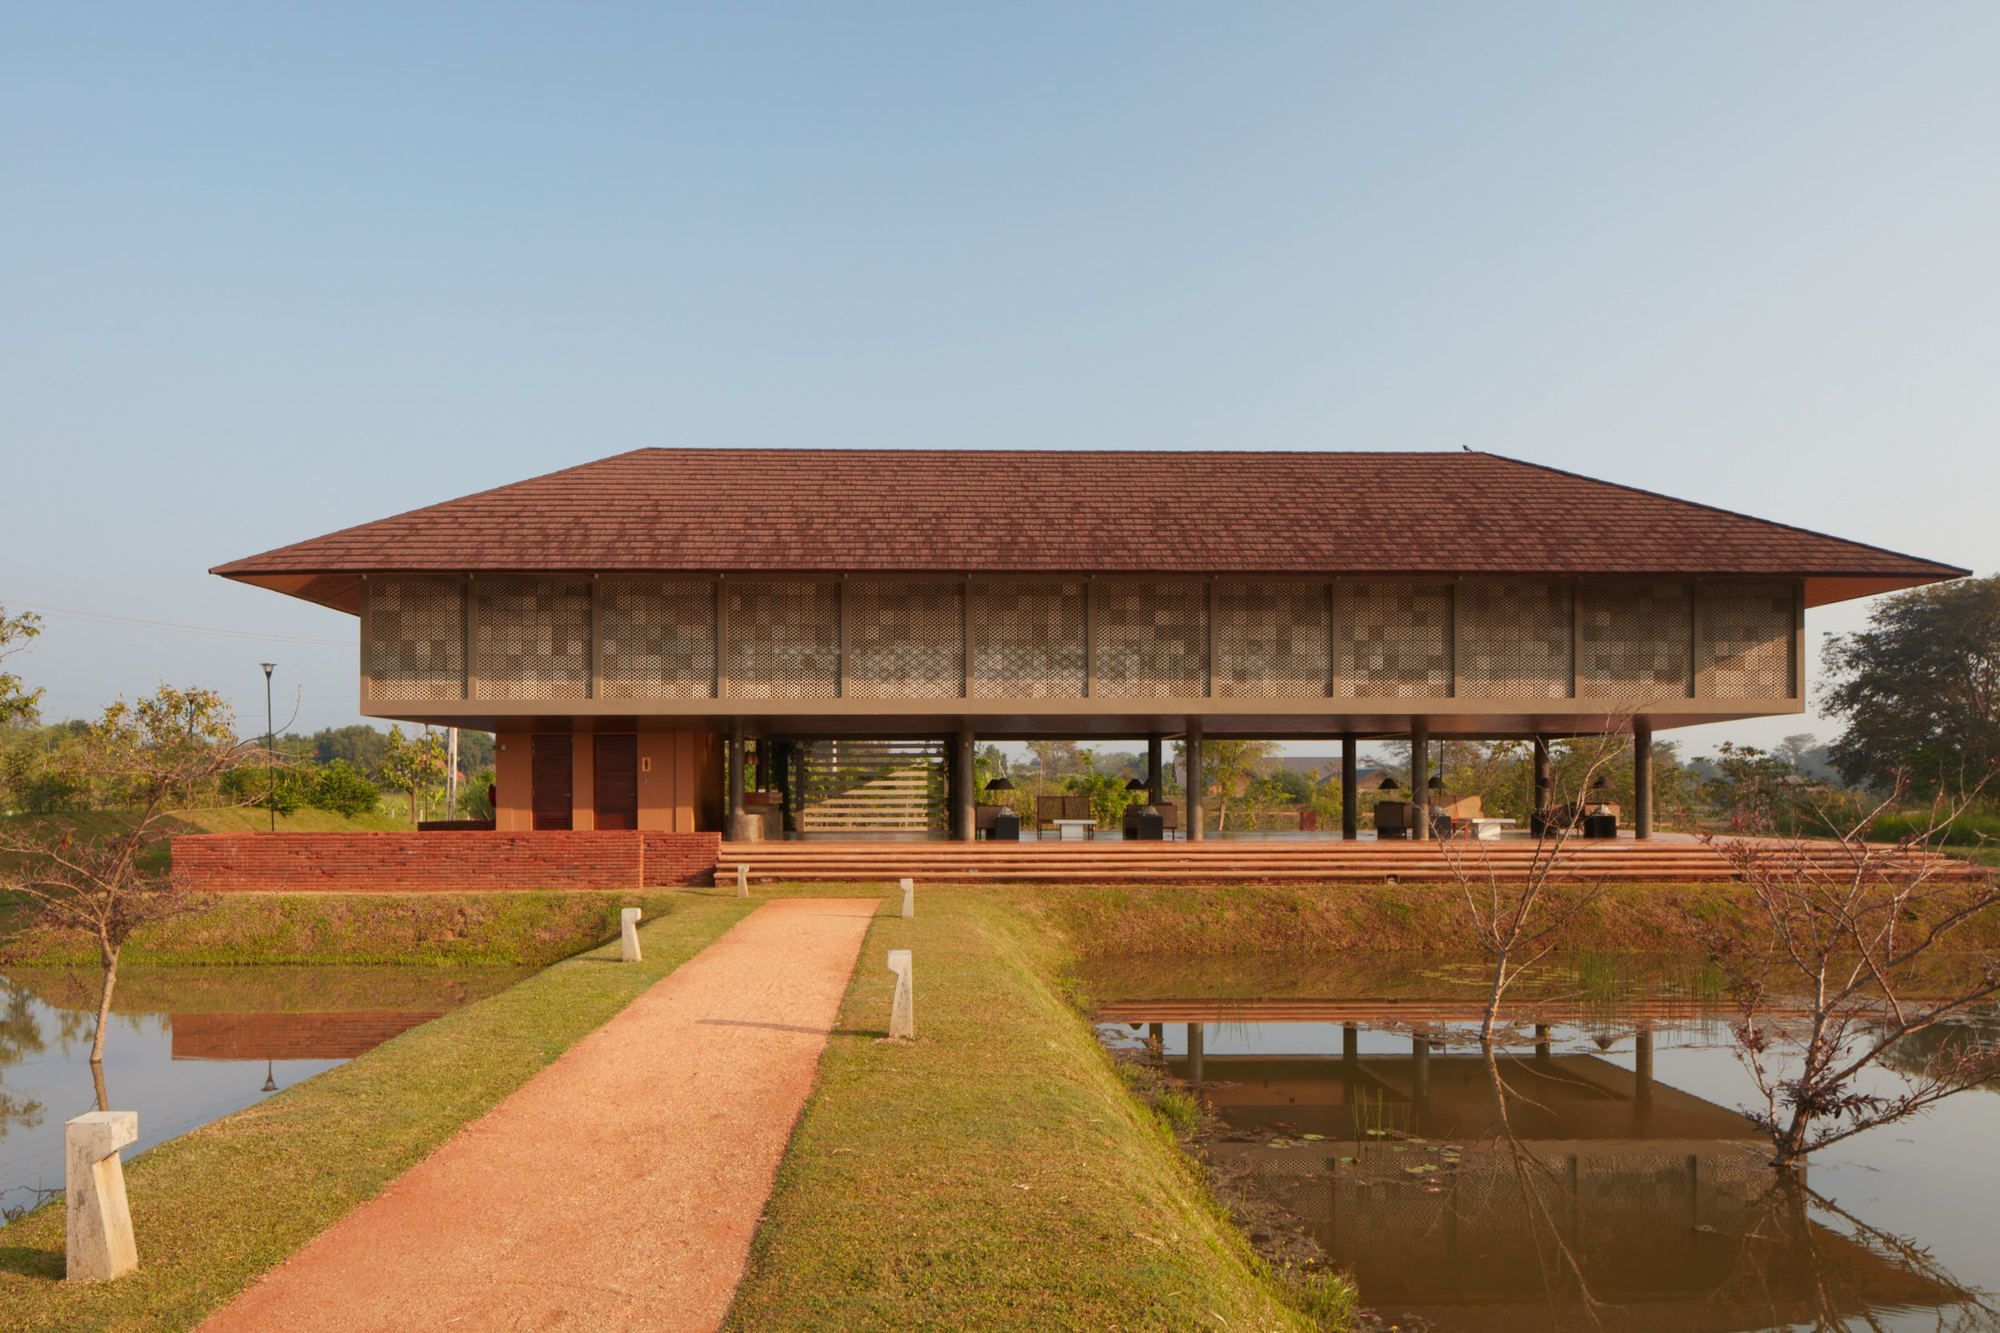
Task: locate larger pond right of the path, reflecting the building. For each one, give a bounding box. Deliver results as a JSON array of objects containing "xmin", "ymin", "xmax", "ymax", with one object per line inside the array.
[{"xmin": 1086, "ymin": 959, "xmax": 2000, "ymax": 1329}]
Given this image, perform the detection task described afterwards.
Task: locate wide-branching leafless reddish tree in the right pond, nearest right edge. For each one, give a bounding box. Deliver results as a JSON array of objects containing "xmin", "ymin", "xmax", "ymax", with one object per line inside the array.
[{"xmin": 1712, "ymin": 783, "xmax": 2000, "ymax": 1171}]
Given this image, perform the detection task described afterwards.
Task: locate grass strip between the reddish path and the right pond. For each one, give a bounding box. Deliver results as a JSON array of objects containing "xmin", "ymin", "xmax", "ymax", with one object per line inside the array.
[{"xmin": 728, "ymin": 887, "xmax": 1346, "ymax": 1329}]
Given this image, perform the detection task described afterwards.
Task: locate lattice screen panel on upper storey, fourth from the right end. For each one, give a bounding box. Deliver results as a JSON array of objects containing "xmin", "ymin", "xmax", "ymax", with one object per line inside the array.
[{"xmin": 1334, "ymin": 582, "xmax": 1452, "ymax": 699}]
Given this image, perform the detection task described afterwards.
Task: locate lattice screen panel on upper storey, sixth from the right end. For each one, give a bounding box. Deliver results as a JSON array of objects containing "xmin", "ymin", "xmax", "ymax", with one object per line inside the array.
[{"xmin": 1090, "ymin": 578, "xmax": 1208, "ymax": 699}]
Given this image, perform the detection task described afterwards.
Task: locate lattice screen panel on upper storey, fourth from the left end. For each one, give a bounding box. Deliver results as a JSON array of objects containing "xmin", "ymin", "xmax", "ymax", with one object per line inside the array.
[{"xmin": 722, "ymin": 578, "xmax": 840, "ymax": 699}]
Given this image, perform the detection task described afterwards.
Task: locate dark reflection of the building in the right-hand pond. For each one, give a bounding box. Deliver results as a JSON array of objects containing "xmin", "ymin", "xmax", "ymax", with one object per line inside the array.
[{"xmin": 1156, "ymin": 1023, "xmax": 1954, "ymax": 1329}]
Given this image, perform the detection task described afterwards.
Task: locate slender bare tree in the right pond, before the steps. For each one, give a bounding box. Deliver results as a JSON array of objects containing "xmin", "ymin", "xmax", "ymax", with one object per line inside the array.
[{"xmin": 1438, "ymin": 719, "xmax": 1630, "ymax": 1045}]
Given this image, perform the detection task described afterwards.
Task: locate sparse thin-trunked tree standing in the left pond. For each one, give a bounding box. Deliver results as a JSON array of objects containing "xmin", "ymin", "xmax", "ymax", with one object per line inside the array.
[{"xmin": 0, "ymin": 687, "xmax": 254, "ymax": 1111}]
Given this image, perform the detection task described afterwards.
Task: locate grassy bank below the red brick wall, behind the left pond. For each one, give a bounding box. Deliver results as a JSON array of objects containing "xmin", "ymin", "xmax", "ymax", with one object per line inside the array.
[{"xmin": 0, "ymin": 891, "xmax": 678, "ymax": 967}]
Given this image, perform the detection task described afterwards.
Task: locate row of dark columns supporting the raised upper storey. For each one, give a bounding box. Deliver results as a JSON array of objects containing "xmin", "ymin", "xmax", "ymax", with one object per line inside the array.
[{"xmin": 726, "ymin": 717, "xmax": 1652, "ymax": 843}]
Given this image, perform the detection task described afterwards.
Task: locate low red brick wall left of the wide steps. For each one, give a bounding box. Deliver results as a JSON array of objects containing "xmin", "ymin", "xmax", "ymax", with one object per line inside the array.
[{"xmin": 174, "ymin": 831, "xmax": 722, "ymax": 893}]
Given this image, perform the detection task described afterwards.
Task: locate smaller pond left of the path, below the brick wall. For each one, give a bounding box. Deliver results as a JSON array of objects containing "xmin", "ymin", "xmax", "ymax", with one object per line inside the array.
[{"xmin": 0, "ymin": 967, "xmax": 528, "ymax": 1215}]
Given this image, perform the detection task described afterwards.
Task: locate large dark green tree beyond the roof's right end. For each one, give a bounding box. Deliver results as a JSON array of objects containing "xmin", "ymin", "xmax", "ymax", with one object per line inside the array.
[{"xmin": 1824, "ymin": 574, "xmax": 2000, "ymax": 791}]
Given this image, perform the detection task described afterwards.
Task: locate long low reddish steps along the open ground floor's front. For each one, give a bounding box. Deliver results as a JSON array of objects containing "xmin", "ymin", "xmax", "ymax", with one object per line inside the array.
[{"xmin": 716, "ymin": 835, "xmax": 1984, "ymax": 885}]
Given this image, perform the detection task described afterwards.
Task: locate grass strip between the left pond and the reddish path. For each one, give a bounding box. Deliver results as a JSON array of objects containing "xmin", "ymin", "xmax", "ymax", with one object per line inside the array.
[{"xmin": 0, "ymin": 897, "xmax": 754, "ymax": 1329}]
